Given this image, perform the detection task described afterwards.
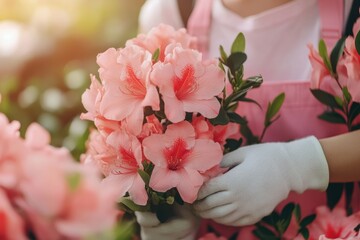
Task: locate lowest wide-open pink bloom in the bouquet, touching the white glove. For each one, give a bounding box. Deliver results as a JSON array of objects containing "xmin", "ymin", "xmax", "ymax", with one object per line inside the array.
[{"xmin": 143, "ymin": 121, "xmax": 223, "ymax": 203}]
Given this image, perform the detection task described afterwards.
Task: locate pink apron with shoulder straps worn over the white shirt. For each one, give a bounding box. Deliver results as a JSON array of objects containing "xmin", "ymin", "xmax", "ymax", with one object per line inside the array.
[{"xmin": 188, "ymin": 0, "xmax": 359, "ymax": 239}]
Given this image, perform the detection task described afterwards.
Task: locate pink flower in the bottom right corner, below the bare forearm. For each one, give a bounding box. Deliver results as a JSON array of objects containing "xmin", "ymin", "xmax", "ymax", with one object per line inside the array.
[{"xmin": 309, "ymin": 206, "xmax": 360, "ymax": 240}]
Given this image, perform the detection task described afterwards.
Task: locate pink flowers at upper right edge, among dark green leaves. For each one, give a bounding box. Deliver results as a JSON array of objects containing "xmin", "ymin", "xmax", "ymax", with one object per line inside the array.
[{"xmin": 309, "ymin": 18, "xmax": 360, "ymax": 102}]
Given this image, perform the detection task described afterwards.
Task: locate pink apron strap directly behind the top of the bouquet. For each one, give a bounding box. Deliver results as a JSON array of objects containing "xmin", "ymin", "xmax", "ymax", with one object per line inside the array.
[{"xmin": 187, "ymin": 0, "xmax": 213, "ymax": 58}]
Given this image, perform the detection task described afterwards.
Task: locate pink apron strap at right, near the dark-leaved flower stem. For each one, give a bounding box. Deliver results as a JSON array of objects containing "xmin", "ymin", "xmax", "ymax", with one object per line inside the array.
[{"xmin": 318, "ymin": 0, "xmax": 344, "ymax": 50}]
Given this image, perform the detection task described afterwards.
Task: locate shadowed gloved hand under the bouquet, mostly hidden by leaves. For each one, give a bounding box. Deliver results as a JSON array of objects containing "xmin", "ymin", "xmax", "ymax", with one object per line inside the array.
[{"xmin": 135, "ymin": 206, "xmax": 200, "ymax": 240}]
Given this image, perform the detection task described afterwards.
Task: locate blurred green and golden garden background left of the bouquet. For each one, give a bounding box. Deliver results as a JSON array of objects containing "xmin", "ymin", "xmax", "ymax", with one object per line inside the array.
[{"xmin": 0, "ymin": 0, "xmax": 144, "ymax": 159}]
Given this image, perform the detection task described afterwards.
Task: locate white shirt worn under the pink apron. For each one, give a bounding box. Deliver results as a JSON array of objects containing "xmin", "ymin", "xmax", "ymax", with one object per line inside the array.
[{"xmin": 139, "ymin": 0, "xmax": 352, "ymax": 81}]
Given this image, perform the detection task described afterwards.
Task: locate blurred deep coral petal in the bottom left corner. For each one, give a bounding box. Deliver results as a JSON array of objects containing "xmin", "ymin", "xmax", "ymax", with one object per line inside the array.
[{"xmin": 0, "ymin": 188, "xmax": 26, "ymax": 240}]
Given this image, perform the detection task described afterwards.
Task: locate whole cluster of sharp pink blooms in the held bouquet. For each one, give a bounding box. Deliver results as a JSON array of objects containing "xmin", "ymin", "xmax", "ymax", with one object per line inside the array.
[{"xmin": 81, "ymin": 25, "xmax": 236, "ymax": 205}]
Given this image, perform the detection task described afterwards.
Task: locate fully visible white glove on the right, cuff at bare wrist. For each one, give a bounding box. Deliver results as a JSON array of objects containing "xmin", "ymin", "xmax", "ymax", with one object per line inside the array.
[{"xmin": 194, "ymin": 137, "xmax": 329, "ymax": 226}]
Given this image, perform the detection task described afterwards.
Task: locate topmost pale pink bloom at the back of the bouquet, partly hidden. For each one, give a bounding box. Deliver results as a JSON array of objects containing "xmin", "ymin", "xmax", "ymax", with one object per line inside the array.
[{"xmin": 126, "ymin": 24, "xmax": 196, "ymax": 61}]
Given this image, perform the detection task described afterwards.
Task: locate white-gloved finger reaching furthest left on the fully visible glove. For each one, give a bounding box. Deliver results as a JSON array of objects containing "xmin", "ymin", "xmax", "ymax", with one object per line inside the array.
[{"xmin": 193, "ymin": 191, "xmax": 233, "ymax": 212}]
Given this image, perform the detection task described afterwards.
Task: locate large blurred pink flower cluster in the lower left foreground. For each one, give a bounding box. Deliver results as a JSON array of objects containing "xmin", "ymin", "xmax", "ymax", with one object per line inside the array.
[{"xmin": 0, "ymin": 109, "xmax": 118, "ymax": 240}]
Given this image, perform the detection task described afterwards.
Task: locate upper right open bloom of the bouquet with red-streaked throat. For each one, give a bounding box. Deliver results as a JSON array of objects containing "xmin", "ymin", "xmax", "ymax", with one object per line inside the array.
[{"xmin": 151, "ymin": 45, "xmax": 224, "ymax": 123}]
